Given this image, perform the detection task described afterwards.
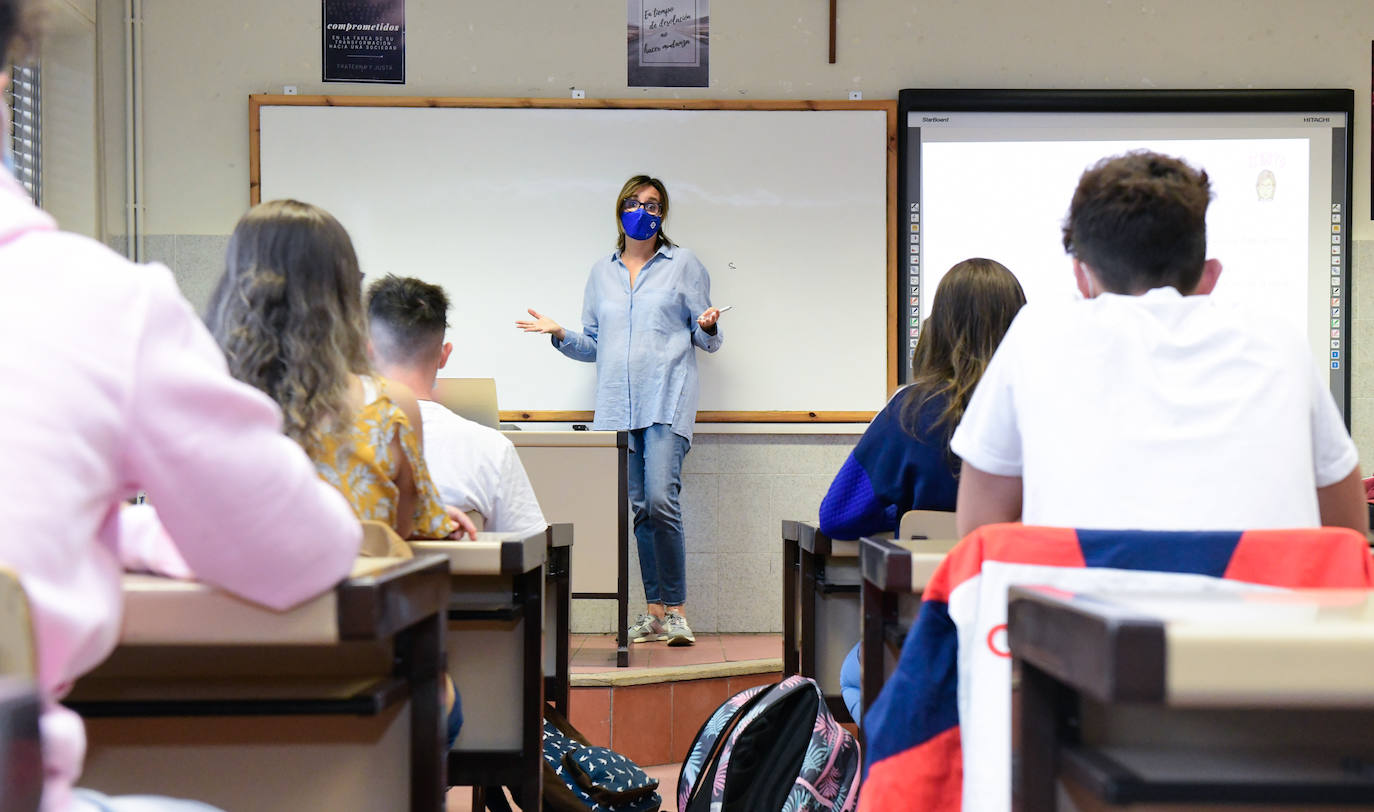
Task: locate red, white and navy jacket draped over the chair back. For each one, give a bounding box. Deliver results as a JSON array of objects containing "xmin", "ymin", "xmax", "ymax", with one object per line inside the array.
[{"xmin": 859, "ymin": 523, "xmax": 1374, "ymax": 812}]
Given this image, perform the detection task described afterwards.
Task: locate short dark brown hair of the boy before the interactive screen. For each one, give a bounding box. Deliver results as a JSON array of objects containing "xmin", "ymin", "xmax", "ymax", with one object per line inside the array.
[{"xmin": 1063, "ymin": 150, "xmax": 1212, "ymax": 294}]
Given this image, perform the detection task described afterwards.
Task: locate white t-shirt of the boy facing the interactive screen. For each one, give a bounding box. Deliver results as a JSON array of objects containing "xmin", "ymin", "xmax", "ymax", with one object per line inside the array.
[{"xmin": 951, "ymin": 287, "xmax": 1358, "ymax": 530}]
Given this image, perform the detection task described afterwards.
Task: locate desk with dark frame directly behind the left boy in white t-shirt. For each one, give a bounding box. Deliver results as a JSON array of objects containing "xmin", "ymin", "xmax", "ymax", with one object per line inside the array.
[{"xmin": 411, "ymin": 530, "xmax": 550, "ymax": 798}]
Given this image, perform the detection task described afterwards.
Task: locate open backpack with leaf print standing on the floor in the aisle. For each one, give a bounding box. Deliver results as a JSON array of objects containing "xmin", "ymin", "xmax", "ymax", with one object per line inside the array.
[{"xmin": 677, "ymin": 676, "xmax": 860, "ymax": 812}]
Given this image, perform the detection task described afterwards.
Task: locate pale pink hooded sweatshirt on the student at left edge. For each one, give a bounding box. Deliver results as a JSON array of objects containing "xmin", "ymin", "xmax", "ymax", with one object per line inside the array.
[{"xmin": 0, "ymin": 170, "xmax": 361, "ymax": 812}]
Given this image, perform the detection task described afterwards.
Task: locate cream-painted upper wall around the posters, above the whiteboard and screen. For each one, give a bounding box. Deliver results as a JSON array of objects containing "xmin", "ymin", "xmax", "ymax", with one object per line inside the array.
[{"xmin": 102, "ymin": 0, "xmax": 1374, "ymax": 239}]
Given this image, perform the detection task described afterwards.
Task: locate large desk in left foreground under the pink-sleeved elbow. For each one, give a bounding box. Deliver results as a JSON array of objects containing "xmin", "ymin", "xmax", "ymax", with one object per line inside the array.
[{"xmin": 66, "ymin": 556, "xmax": 448, "ymax": 812}]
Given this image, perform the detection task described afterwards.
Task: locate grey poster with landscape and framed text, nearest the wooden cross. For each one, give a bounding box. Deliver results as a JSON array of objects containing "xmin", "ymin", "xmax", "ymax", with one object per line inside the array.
[{"xmin": 625, "ymin": 0, "xmax": 710, "ymax": 88}]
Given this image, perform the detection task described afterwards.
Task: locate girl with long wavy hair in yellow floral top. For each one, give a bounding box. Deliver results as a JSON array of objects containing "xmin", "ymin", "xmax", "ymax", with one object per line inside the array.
[{"xmin": 207, "ymin": 201, "xmax": 473, "ymax": 539}]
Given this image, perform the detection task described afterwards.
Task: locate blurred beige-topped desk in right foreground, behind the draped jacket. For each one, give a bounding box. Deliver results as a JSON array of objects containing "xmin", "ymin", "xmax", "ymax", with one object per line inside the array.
[{"xmin": 1007, "ymin": 587, "xmax": 1374, "ymax": 811}]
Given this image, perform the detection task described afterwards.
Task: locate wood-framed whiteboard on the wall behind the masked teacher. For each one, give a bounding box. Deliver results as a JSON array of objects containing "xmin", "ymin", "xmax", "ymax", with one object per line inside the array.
[{"xmin": 254, "ymin": 98, "xmax": 892, "ymax": 419}]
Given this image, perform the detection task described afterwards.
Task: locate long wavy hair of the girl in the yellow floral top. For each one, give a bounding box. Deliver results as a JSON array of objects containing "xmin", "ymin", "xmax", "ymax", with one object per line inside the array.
[{"xmin": 206, "ymin": 201, "xmax": 371, "ymax": 456}]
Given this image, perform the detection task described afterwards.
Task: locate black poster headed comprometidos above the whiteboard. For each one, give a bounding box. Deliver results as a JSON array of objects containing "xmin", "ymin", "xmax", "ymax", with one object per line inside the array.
[{"xmin": 322, "ymin": 0, "xmax": 405, "ymax": 85}]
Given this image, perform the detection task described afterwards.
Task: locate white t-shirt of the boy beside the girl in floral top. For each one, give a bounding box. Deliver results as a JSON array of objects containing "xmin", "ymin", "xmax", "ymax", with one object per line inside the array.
[{"xmin": 419, "ymin": 400, "xmax": 548, "ymax": 536}]
